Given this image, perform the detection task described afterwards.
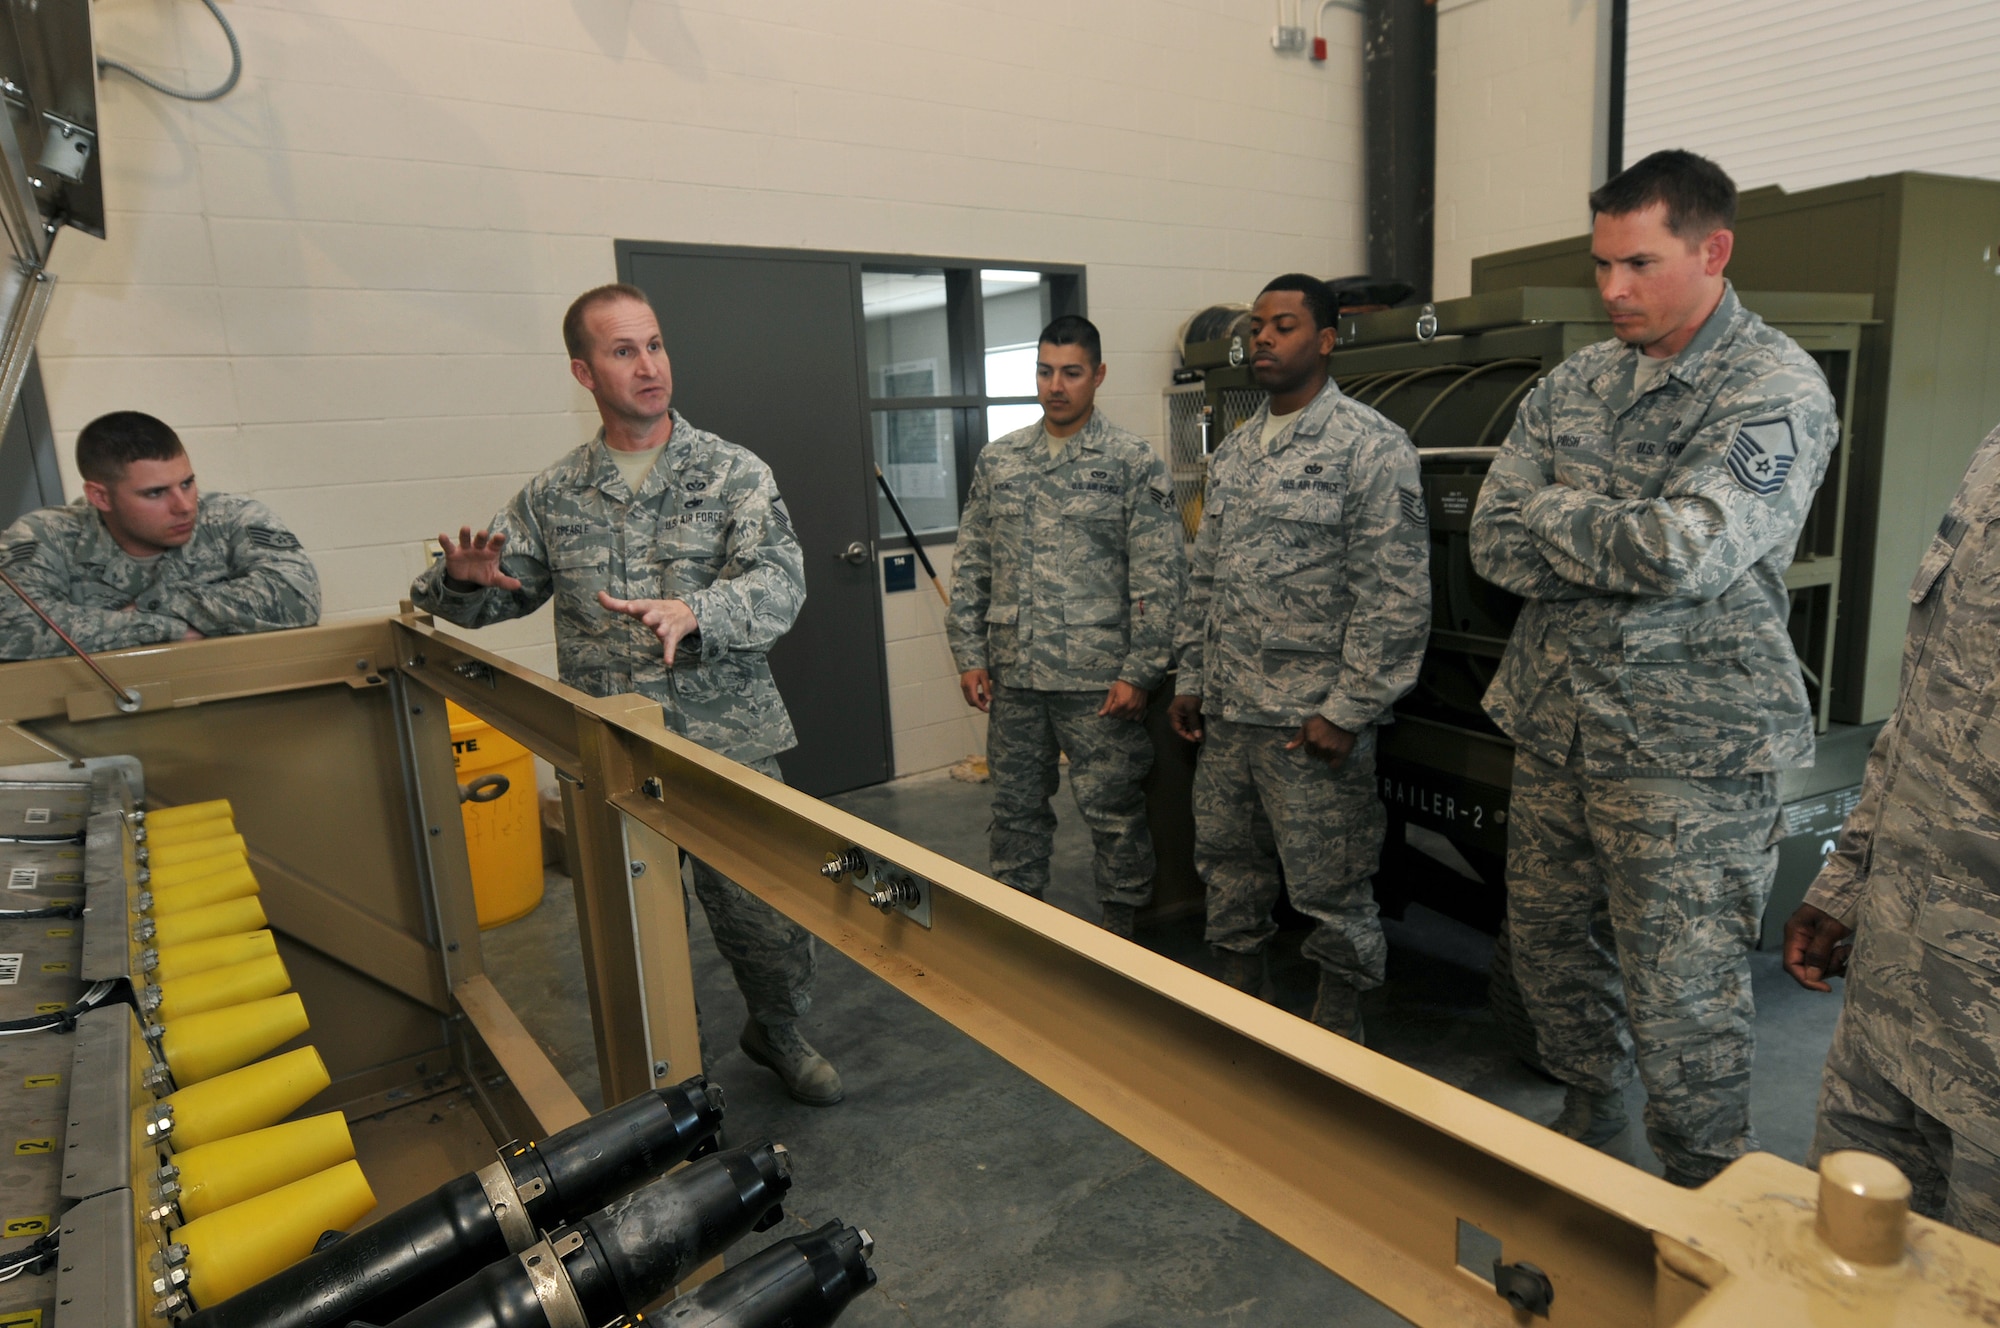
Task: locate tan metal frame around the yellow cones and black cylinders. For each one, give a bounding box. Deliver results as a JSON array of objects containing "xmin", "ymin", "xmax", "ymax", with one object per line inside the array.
[{"xmin": 0, "ymin": 616, "xmax": 2000, "ymax": 1328}]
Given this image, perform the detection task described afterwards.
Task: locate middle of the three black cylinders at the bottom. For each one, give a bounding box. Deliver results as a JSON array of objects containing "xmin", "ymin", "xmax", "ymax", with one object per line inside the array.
[{"xmin": 378, "ymin": 1144, "xmax": 792, "ymax": 1328}]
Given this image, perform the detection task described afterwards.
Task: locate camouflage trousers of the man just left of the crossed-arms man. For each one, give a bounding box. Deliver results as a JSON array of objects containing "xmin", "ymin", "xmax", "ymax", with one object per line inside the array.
[{"xmin": 1194, "ymin": 718, "xmax": 1388, "ymax": 992}]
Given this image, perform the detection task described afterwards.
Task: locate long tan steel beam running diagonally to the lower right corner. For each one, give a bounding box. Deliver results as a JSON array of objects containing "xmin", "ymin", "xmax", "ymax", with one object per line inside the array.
[{"xmin": 552, "ymin": 698, "xmax": 2000, "ymax": 1324}]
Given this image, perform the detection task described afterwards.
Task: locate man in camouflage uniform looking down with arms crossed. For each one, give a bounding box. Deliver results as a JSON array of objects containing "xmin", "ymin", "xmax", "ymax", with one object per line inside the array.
[{"xmin": 1472, "ymin": 152, "xmax": 1838, "ymax": 1184}]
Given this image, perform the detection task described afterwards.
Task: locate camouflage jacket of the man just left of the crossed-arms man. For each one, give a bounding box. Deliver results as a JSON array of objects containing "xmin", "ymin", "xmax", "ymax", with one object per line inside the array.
[{"xmin": 1174, "ymin": 382, "xmax": 1430, "ymax": 734}]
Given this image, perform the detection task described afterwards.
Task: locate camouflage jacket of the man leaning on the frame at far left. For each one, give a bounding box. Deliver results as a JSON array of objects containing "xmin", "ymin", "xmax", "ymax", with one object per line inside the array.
[{"xmin": 0, "ymin": 494, "xmax": 320, "ymax": 660}]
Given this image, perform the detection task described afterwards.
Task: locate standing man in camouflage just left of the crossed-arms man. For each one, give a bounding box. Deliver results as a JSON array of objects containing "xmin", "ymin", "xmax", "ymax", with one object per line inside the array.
[{"xmin": 1172, "ymin": 274, "xmax": 1430, "ymax": 1040}]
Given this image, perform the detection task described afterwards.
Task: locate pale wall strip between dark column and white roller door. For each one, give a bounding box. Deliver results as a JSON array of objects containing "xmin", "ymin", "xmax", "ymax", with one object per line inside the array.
[{"xmin": 1434, "ymin": 0, "xmax": 1604, "ymax": 300}]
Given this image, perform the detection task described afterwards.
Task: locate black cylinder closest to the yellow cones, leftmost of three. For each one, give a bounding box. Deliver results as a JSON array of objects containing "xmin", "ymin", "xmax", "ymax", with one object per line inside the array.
[{"xmin": 184, "ymin": 1078, "xmax": 722, "ymax": 1328}]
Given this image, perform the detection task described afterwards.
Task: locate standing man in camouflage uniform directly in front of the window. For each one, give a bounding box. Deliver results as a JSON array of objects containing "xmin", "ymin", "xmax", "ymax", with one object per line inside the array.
[{"xmin": 946, "ymin": 314, "xmax": 1188, "ymax": 936}]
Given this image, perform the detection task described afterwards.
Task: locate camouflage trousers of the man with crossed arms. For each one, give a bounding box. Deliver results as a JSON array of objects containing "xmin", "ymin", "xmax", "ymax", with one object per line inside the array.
[{"xmin": 1506, "ymin": 748, "xmax": 1778, "ymax": 1184}]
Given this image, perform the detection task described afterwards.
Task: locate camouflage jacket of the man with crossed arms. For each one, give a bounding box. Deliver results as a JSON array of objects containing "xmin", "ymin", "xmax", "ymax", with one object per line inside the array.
[{"xmin": 1472, "ymin": 290, "xmax": 1838, "ymax": 776}]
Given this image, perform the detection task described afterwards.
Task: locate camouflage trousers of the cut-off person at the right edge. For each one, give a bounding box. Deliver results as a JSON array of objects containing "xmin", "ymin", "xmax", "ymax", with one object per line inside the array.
[{"xmin": 1806, "ymin": 996, "xmax": 2000, "ymax": 1240}]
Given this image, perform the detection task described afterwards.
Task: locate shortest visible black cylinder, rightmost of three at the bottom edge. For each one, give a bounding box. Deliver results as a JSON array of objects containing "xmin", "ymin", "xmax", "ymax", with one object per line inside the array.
[{"xmin": 656, "ymin": 1222, "xmax": 874, "ymax": 1328}]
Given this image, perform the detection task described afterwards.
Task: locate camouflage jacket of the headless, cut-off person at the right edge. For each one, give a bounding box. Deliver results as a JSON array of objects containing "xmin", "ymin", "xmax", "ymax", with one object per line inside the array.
[{"xmin": 1806, "ymin": 420, "xmax": 2000, "ymax": 1152}]
